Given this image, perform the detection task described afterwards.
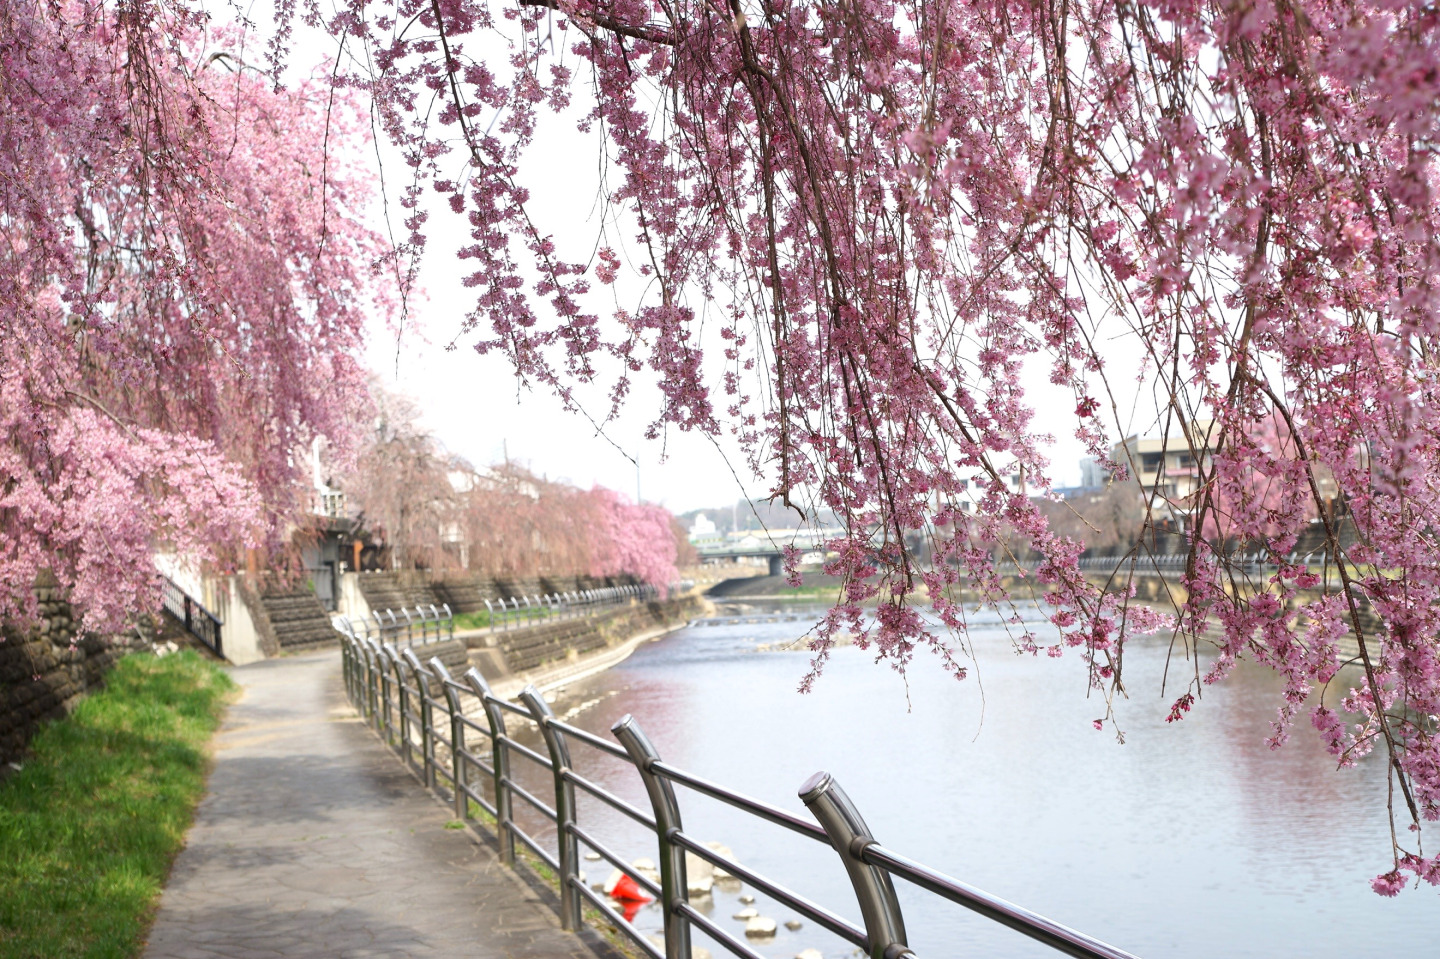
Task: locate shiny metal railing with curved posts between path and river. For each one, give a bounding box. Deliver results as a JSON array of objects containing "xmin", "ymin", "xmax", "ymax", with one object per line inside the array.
[{"xmin": 341, "ymin": 619, "xmax": 1135, "ymax": 959}]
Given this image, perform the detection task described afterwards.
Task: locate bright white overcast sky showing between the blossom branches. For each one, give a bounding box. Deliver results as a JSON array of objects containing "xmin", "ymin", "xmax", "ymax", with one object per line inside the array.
[{"xmin": 272, "ymin": 11, "xmax": 1145, "ymax": 513}]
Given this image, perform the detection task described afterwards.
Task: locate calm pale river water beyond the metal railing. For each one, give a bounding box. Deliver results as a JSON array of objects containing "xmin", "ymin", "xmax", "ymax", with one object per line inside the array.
[{"xmin": 506, "ymin": 605, "xmax": 1440, "ymax": 959}]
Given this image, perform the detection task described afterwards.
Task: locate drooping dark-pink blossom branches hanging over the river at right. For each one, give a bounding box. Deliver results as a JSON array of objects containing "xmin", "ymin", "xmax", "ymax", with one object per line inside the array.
[{"xmin": 318, "ymin": 0, "xmax": 1440, "ymax": 894}]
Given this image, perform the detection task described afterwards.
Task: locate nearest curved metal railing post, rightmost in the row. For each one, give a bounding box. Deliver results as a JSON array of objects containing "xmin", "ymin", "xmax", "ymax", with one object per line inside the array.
[{"xmin": 799, "ymin": 772, "xmax": 910, "ymax": 959}]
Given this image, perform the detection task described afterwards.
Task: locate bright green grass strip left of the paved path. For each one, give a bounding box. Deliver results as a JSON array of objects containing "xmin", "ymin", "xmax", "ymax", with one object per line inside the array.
[{"xmin": 0, "ymin": 651, "xmax": 235, "ymax": 959}]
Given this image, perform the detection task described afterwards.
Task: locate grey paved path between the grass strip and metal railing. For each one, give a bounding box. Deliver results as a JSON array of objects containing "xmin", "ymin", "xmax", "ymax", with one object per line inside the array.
[{"xmin": 144, "ymin": 652, "xmax": 596, "ymax": 959}]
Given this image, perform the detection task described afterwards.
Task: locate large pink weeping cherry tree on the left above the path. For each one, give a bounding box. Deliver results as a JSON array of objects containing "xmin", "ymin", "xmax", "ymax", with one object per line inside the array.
[{"xmin": 0, "ymin": 7, "xmax": 384, "ymax": 629}]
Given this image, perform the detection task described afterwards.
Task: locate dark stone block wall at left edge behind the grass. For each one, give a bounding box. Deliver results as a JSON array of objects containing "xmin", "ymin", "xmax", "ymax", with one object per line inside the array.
[{"xmin": 0, "ymin": 585, "xmax": 130, "ymax": 763}]
